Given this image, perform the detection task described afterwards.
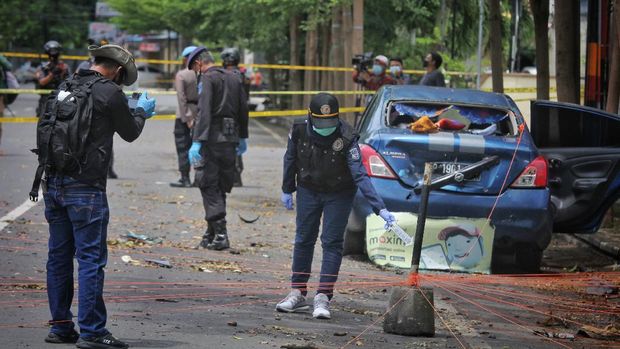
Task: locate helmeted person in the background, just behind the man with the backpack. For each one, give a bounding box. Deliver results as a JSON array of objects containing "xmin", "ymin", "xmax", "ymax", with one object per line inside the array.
[{"xmin": 36, "ymin": 40, "xmax": 71, "ymax": 118}]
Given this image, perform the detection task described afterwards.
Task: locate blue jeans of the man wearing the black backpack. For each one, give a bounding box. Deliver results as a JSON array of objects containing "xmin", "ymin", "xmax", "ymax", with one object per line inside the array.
[{"xmin": 44, "ymin": 177, "xmax": 110, "ymax": 338}]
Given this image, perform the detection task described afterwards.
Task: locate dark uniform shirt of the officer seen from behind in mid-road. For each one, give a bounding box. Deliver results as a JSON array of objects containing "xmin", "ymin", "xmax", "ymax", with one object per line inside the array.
[{"xmin": 193, "ymin": 66, "xmax": 248, "ymax": 143}]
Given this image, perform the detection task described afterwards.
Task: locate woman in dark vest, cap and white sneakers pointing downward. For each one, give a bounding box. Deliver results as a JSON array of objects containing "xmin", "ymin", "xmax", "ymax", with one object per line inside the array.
[{"xmin": 276, "ymin": 93, "xmax": 396, "ymax": 319}]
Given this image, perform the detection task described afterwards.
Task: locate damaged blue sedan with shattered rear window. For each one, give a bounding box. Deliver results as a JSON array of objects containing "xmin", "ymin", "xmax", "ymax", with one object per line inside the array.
[{"xmin": 344, "ymin": 86, "xmax": 620, "ymax": 272}]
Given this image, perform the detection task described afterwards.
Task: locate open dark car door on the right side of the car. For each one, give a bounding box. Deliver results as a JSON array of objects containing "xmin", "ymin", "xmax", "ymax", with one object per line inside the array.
[{"xmin": 531, "ymin": 101, "xmax": 620, "ymax": 233}]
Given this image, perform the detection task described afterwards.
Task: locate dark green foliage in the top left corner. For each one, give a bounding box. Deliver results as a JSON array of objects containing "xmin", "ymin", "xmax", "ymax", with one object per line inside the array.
[{"xmin": 0, "ymin": 0, "xmax": 96, "ymax": 51}]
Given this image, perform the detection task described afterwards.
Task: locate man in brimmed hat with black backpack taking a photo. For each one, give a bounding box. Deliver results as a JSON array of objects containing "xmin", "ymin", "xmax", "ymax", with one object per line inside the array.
[{"xmin": 30, "ymin": 45, "xmax": 155, "ymax": 349}]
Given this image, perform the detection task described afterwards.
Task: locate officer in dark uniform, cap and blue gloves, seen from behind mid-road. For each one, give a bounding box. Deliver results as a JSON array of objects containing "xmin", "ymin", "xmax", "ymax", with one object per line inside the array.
[{"xmin": 188, "ymin": 47, "xmax": 249, "ymax": 251}]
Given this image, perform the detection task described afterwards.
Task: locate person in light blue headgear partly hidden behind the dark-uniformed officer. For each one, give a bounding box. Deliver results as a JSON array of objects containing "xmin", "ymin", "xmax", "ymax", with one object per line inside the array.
[{"xmin": 170, "ymin": 46, "xmax": 198, "ymax": 188}]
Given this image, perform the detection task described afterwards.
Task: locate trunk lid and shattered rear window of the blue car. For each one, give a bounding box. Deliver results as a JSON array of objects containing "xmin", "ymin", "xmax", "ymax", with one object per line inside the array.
[{"xmin": 373, "ymin": 102, "xmax": 532, "ymax": 195}]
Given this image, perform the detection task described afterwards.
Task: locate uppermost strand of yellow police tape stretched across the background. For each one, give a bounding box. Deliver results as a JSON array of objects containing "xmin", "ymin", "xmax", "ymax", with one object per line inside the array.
[{"xmin": 0, "ymin": 52, "xmax": 475, "ymax": 75}]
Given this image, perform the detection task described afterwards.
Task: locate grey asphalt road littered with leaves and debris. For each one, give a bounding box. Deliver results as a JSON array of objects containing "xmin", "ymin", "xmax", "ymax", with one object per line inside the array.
[{"xmin": 0, "ymin": 104, "xmax": 618, "ymax": 348}]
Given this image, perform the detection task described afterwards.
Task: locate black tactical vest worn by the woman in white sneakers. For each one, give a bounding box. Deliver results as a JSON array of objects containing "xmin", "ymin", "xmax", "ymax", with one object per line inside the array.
[{"xmin": 291, "ymin": 120, "xmax": 357, "ymax": 193}]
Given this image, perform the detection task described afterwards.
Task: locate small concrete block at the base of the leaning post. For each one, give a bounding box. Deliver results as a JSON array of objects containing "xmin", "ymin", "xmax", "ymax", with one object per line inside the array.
[{"xmin": 383, "ymin": 287, "xmax": 435, "ymax": 337}]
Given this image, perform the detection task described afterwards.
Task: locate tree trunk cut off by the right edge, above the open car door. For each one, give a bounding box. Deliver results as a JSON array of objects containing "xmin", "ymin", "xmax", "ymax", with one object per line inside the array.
[{"xmin": 605, "ymin": 0, "xmax": 620, "ymax": 114}]
